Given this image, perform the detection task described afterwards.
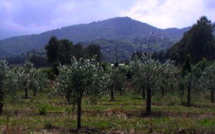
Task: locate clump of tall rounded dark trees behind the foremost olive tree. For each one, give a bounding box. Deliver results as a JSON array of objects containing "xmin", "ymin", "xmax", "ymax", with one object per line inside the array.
[{"xmin": 45, "ymin": 37, "xmax": 102, "ymax": 65}]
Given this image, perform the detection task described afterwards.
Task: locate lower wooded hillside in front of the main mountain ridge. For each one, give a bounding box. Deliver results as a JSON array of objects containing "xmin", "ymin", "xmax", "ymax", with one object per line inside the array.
[{"xmin": 81, "ymin": 34, "xmax": 174, "ymax": 63}]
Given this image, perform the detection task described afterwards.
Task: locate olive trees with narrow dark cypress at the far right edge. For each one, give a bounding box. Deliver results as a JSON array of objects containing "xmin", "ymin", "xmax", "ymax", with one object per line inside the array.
[{"xmin": 179, "ymin": 55, "xmax": 215, "ymax": 106}]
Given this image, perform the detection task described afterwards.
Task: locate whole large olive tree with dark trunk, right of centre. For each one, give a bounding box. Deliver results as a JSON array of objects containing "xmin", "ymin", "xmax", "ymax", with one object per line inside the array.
[{"xmin": 130, "ymin": 54, "xmax": 173, "ymax": 115}]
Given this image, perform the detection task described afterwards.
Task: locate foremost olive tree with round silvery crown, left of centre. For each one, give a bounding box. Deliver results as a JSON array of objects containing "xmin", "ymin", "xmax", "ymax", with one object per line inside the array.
[{"xmin": 57, "ymin": 58, "xmax": 106, "ymax": 129}]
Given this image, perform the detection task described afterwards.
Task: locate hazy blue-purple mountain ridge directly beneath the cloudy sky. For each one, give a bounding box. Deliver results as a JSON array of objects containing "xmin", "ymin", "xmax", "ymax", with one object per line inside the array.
[{"xmin": 0, "ymin": 17, "xmax": 189, "ymax": 56}]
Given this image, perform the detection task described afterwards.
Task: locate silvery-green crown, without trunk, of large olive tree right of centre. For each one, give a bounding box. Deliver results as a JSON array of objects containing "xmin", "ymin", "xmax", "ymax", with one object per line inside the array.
[{"xmin": 130, "ymin": 54, "xmax": 175, "ymax": 94}]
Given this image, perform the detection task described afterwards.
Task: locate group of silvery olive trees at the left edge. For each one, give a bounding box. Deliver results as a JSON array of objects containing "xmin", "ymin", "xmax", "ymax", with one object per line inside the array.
[{"xmin": 0, "ymin": 60, "xmax": 47, "ymax": 114}]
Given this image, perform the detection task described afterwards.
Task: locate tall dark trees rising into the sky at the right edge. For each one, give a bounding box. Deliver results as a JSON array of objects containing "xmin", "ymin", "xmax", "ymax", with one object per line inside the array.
[{"xmin": 153, "ymin": 16, "xmax": 215, "ymax": 65}]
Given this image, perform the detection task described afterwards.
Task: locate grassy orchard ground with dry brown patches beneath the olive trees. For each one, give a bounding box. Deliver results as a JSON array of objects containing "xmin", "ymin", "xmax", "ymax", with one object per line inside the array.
[{"xmin": 0, "ymin": 89, "xmax": 215, "ymax": 134}]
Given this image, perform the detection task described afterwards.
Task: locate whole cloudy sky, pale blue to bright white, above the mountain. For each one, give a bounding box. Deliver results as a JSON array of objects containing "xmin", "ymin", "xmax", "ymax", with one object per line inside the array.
[{"xmin": 0, "ymin": 0, "xmax": 215, "ymax": 39}]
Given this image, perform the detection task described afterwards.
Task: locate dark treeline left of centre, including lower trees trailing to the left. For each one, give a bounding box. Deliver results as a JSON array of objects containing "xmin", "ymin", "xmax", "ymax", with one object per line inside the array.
[{"xmin": 3, "ymin": 37, "xmax": 102, "ymax": 68}]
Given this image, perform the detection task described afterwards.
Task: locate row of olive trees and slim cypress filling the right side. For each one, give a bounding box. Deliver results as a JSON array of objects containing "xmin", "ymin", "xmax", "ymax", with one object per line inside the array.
[{"xmin": 130, "ymin": 54, "xmax": 215, "ymax": 115}]
